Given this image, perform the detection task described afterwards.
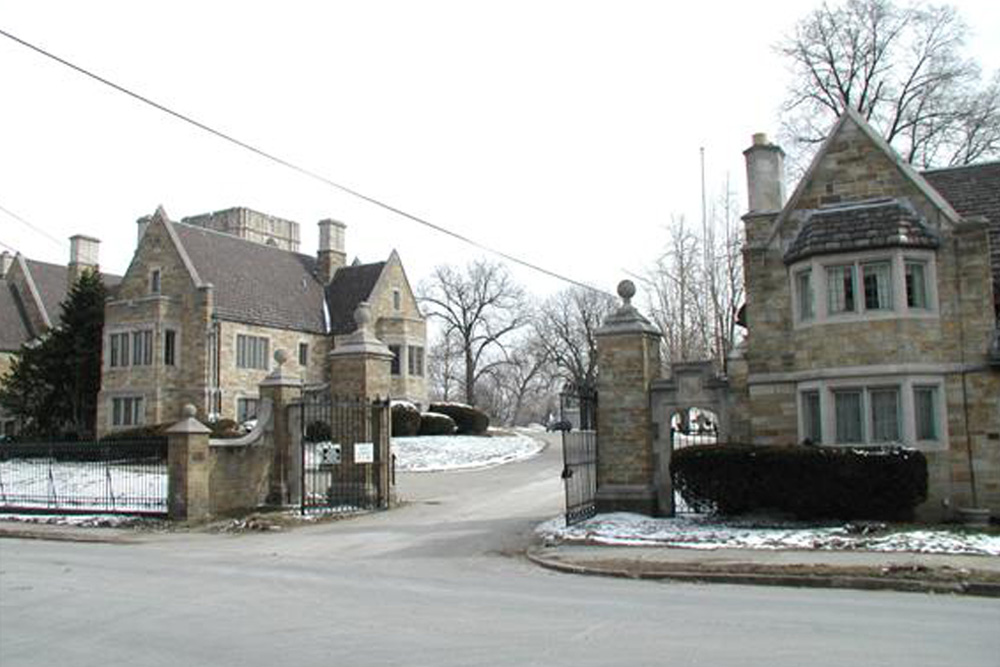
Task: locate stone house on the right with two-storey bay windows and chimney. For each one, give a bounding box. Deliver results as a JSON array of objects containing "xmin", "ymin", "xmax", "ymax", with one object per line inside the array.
[{"xmin": 731, "ymin": 111, "xmax": 1000, "ymax": 518}]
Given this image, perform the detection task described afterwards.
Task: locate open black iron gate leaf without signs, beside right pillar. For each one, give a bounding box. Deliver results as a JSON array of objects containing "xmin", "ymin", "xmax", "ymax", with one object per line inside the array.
[{"xmin": 559, "ymin": 387, "xmax": 597, "ymax": 526}]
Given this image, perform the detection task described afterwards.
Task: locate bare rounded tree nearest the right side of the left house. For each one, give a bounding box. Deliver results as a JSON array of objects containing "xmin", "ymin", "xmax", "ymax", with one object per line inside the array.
[{"xmin": 420, "ymin": 260, "xmax": 527, "ymax": 405}]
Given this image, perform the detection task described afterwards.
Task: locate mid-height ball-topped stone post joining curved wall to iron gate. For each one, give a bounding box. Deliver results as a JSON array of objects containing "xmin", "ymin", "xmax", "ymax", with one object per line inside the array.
[{"xmin": 260, "ymin": 350, "xmax": 302, "ymax": 505}]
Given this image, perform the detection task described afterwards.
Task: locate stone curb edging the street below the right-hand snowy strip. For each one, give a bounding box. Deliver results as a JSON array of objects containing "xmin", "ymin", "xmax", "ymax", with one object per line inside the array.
[{"xmin": 526, "ymin": 549, "xmax": 1000, "ymax": 598}]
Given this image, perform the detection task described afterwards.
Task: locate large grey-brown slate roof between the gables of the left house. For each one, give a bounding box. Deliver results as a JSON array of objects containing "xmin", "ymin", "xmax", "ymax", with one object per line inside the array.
[{"xmin": 170, "ymin": 222, "xmax": 326, "ymax": 333}]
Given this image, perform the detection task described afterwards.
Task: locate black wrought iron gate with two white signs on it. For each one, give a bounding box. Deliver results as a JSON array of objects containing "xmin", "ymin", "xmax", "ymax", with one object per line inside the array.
[{"xmin": 300, "ymin": 392, "xmax": 394, "ymax": 514}]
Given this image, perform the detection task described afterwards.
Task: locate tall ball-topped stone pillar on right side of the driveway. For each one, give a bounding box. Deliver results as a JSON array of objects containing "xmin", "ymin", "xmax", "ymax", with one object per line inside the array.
[{"xmin": 596, "ymin": 280, "xmax": 662, "ymax": 515}]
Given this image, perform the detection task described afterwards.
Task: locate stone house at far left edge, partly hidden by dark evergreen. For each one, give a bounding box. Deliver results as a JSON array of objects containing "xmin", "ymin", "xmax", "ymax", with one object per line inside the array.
[{"xmin": 0, "ymin": 240, "xmax": 121, "ymax": 436}]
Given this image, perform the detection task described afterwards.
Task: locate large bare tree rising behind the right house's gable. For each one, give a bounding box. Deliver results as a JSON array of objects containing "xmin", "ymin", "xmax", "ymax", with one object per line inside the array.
[{"xmin": 776, "ymin": 0, "xmax": 1000, "ymax": 167}]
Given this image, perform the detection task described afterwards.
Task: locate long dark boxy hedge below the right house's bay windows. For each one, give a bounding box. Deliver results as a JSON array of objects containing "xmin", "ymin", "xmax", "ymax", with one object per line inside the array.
[{"xmin": 670, "ymin": 445, "xmax": 927, "ymax": 520}]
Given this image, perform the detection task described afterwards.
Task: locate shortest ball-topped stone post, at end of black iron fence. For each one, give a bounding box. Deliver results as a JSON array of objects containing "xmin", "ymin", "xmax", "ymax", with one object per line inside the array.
[{"xmin": 167, "ymin": 404, "xmax": 211, "ymax": 521}]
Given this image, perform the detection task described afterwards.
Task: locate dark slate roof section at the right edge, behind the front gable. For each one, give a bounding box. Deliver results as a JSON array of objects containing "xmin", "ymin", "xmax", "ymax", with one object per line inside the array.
[{"xmin": 921, "ymin": 162, "xmax": 1000, "ymax": 288}]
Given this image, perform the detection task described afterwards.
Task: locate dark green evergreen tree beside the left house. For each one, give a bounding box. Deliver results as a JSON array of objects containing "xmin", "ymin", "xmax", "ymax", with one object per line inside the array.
[{"xmin": 0, "ymin": 272, "xmax": 107, "ymax": 436}]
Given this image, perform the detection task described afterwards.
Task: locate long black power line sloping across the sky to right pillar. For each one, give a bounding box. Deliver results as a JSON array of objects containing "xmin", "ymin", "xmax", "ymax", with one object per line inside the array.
[{"xmin": 0, "ymin": 28, "xmax": 604, "ymax": 292}]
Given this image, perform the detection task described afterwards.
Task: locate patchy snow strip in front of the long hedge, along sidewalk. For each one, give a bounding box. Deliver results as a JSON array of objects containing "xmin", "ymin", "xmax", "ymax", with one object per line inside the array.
[{"xmin": 537, "ymin": 512, "xmax": 1000, "ymax": 556}]
